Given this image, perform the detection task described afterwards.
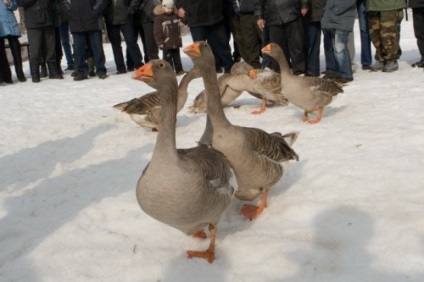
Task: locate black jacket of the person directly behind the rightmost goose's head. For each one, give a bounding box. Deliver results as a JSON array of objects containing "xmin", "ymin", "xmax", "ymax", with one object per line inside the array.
[{"xmin": 255, "ymin": 0, "xmax": 309, "ymax": 25}]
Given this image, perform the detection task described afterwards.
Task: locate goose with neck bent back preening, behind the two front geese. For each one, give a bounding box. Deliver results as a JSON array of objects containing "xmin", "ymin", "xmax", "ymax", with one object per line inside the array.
[{"xmin": 189, "ymin": 62, "xmax": 288, "ymax": 114}]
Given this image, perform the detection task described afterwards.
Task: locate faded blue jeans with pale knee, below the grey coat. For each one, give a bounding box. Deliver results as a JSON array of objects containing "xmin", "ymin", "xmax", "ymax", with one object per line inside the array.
[{"xmin": 323, "ymin": 29, "xmax": 353, "ymax": 79}]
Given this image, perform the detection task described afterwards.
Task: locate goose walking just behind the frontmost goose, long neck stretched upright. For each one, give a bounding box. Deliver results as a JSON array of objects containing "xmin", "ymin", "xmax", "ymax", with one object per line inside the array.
[{"xmin": 184, "ymin": 41, "xmax": 299, "ymax": 220}]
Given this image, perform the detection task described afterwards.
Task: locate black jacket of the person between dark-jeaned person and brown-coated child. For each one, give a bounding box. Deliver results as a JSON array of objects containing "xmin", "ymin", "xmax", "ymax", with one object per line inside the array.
[{"xmin": 104, "ymin": 0, "xmax": 140, "ymax": 25}]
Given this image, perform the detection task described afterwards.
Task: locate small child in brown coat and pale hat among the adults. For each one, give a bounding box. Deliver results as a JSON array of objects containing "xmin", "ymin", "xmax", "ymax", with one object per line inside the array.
[{"xmin": 153, "ymin": 0, "xmax": 186, "ymax": 75}]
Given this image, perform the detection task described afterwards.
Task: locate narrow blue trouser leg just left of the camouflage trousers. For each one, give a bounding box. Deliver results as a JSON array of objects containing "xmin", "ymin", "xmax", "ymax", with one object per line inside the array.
[{"xmin": 356, "ymin": 0, "xmax": 372, "ymax": 66}]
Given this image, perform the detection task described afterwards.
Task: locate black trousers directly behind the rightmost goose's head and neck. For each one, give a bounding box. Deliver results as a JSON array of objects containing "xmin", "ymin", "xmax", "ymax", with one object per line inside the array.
[{"xmin": 269, "ymin": 17, "xmax": 306, "ymax": 74}]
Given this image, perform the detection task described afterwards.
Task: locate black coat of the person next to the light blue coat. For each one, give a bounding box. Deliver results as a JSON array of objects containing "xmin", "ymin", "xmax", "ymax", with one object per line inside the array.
[{"xmin": 17, "ymin": 0, "xmax": 54, "ymax": 28}]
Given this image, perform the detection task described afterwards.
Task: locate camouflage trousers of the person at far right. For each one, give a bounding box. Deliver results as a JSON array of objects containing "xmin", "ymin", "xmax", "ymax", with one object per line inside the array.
[{"xmin": 368, "ymin": 9, "xmax": 403, "ymax": 62}]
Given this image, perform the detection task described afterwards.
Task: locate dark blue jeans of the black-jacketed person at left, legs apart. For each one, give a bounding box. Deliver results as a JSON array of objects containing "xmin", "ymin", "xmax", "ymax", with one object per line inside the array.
[{"xmin": 72, "ymin": 30, "xmax": 106, "ymax": 76}]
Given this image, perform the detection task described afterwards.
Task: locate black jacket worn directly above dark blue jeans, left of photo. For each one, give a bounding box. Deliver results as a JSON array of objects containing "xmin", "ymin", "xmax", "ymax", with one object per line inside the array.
[{"xmin": 69, "ymin": 0, "xmax": 109, "ymax": 32}]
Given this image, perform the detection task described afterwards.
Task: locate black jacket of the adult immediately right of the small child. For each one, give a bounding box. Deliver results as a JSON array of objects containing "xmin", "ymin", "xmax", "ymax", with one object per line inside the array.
[{"xmin": 175, "ymin": 0, "xmax": 224, "ymax": 27}]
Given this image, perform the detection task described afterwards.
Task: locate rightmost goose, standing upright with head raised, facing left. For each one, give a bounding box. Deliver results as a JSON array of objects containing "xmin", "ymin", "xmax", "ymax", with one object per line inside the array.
[{"xmin": 262, "ymin": 43, "xmax": 343, "ymax": 124}]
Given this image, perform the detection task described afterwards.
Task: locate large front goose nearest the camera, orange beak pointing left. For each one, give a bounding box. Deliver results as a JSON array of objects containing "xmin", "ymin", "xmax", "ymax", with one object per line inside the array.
[{"xmin": 132, "ymin": 60, "xmax": 236, "ymax": 263}]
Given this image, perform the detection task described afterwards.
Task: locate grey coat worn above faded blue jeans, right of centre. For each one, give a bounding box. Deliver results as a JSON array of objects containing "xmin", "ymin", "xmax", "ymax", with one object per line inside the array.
[{"xmin": 321, "ymin": 0, "xmax": 356, "ymax": 31}]
